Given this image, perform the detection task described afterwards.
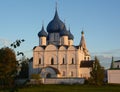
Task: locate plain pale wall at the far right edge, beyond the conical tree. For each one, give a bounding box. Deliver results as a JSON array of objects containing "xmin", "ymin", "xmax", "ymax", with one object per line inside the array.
[{"xmin": 107, "ymin": 70, "xmax": 120, "ymax": 84}]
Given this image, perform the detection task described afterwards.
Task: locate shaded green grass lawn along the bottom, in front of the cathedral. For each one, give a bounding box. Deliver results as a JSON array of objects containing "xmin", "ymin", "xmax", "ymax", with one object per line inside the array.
[{"xmin": 18, "ymin": 85, "xmax": 120, "ymax": 92}]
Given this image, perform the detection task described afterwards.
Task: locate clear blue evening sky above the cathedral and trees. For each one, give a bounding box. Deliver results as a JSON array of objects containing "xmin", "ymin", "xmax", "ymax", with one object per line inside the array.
[{"xmin": 0, "ymin": 0, "xmax": 120, "ymax": 67}]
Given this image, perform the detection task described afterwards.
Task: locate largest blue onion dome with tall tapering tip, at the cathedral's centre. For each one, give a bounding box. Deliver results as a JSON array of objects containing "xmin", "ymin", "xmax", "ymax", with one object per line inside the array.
[{"xmin": 47, "ymin": 9, "xmax": 65, "ymax": 33}]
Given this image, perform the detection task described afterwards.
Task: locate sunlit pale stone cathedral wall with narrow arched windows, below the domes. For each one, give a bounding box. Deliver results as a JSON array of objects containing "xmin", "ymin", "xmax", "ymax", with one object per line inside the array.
[{"xmin": 33, "ymin": 45, "xmax": 90, "ymax": 77}]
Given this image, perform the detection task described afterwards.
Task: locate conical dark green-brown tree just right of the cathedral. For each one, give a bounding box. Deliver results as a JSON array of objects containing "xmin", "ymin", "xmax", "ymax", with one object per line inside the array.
[{"xmin": 89, "ymin": 57, "xmax": 105, "ymax": 85}]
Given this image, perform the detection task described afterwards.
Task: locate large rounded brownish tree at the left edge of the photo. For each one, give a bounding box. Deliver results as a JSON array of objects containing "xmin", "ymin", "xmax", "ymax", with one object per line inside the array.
[{"xmin": 0, "ymin": 47, "xmax": 17, "ymax": 86}]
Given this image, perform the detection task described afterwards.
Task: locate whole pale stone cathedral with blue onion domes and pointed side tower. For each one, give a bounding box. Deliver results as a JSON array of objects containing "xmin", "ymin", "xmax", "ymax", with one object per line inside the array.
[{"xmin": 29, "ymin": 9, "xmax": 93, "ymax": 78}]
